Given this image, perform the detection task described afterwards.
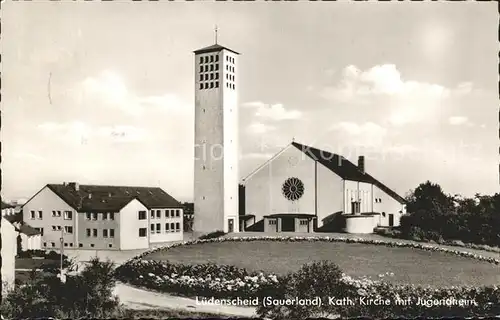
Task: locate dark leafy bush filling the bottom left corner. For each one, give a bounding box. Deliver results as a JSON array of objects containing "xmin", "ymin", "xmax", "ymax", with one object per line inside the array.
[{"xmin": 1, "ymin": 259, "xmax": 119, "ymax": 319}]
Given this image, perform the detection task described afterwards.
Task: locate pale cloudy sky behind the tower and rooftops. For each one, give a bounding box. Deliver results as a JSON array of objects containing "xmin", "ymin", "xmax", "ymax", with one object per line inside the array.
[{"xmin": 1, "ymin": 1, "xmax": 499, "ymax": 201}]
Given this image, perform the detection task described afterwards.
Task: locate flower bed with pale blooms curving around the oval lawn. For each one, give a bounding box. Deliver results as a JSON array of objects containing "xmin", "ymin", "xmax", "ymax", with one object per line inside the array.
[{"xmin": 116, "ymin": 236, "xmax": 500, "ymax": 319}]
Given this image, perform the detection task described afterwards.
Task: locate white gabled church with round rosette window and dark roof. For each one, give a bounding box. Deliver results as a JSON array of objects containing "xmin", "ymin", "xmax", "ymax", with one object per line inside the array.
[{"xmin": 239, "ymin": 142, "xmax": 406, "ymax": 233}]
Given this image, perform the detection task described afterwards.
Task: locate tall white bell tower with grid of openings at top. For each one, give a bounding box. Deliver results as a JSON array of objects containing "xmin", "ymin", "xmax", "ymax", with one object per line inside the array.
[{"xmin": 193, "ymin": 44, "xmax": 239, "ymax": 234}]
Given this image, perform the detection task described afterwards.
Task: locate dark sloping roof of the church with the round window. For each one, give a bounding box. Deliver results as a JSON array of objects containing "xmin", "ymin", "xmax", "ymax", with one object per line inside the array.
[{"xmin": 292, "ymin": 142, "xmax": 406, "ymax": 204}]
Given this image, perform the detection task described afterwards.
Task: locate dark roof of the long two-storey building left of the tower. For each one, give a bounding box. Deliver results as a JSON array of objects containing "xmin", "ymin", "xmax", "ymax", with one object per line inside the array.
[{"xmin": 47, "ymin": 183, "xmax": 182, "ymax": 212}]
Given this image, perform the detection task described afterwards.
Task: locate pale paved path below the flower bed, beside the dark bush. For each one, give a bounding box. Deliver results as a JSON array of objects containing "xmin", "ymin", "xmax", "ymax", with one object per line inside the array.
[{"xmin": 114, "ymin": 282, "xmax": 256, "ymax": 317}]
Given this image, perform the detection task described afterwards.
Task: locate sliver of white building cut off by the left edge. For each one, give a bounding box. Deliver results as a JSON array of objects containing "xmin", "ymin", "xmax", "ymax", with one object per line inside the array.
[{"xmin": 1, "ymin": 217, "xmax": 17, "ymax": 297}]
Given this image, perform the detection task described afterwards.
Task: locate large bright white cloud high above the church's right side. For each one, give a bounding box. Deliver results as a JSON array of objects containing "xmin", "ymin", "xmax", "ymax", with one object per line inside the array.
[{"xmin": 319, "ymin": 64, "xmax": 475, "ymax": 126}]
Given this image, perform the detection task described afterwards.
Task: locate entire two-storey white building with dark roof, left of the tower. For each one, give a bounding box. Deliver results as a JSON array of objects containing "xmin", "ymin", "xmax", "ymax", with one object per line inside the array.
[{"xmin": 23, "ymin": 182, "xmax": 184, "ymax": 250}]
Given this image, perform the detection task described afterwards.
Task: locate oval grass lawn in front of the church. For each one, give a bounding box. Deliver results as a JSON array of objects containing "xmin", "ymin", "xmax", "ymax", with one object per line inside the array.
[{"xmin": 145, "ymin": 241, "xmax": 500, "ymax": 286}]
